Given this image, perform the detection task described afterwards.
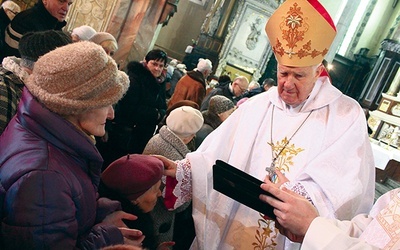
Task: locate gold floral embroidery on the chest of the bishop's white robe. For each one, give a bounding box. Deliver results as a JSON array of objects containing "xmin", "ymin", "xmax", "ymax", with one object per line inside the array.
[{"xmin": 268, "ymin": 137, "xmax": 304, "ymax": 172}]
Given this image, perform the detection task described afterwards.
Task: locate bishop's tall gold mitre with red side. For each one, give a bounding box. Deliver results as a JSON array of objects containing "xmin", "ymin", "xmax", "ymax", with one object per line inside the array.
[{"xmin": 265, "ymin": 0, "xmax": 336, "ymax": 67}]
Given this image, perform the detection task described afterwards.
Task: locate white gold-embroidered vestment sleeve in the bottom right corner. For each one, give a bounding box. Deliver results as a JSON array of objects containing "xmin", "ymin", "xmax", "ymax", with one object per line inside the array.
[{"xmin": 302, "ymin": 188, "xmax": 400, "ymax": 250}]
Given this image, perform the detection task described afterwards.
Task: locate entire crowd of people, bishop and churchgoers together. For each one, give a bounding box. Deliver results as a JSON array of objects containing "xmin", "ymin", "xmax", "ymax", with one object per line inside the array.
[{"xmin": 0, "ymin": 0, "xmax": 400, "ymax": 250}]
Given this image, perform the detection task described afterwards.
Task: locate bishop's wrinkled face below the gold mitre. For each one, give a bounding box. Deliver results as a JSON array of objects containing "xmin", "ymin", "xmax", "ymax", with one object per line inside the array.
[{"xmin": 277, "ymin": 65, "xmax": 322, "ymax": 107}]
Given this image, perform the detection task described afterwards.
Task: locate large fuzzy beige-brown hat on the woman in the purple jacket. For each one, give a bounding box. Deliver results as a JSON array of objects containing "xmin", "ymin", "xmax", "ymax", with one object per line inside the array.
[{"xmin": 25, "ymin": 41, "xmax": 129, "ymax": 115}]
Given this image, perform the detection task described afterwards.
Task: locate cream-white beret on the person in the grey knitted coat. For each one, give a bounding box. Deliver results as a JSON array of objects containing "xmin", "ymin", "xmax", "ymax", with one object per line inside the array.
[{"xmin": 166, "ymin": 106, "xmax": 204, "ymax": 137}]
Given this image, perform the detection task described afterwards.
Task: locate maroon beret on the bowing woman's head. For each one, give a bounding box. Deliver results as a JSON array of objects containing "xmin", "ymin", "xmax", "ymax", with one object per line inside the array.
[{"xmin": 101, "ymin": 154, "xmax": 164, "ymax": 200}]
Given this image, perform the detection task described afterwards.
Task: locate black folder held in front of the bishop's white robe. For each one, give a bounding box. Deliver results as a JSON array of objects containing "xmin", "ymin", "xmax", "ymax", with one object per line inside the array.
[{"xmin": 213, "ymin": 160, "xmax": 276, "ymax": 220}]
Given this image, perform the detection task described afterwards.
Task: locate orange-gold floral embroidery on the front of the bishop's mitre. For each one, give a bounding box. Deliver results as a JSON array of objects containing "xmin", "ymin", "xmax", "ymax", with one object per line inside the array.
[{"xmin": 272, "ymin": 3, "xmax": 328, "ymax": 58}]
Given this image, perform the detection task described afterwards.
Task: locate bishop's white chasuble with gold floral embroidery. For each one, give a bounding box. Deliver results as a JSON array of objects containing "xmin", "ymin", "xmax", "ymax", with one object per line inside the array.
[{"xmin": 187, "ymin": 77, "xmax": 375, "ymax": 250}]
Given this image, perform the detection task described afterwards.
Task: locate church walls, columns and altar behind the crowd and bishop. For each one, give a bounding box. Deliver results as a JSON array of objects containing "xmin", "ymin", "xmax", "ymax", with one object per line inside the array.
[{"xmin": 4, "ymin": 0, "xmax": 400, "ymax": 193}]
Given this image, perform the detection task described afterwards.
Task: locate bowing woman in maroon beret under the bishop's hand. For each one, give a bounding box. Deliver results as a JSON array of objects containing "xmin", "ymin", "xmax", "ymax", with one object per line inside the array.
[{"xmin": 100, "ymin": 154, "xmax": 173, "ymax": 250}]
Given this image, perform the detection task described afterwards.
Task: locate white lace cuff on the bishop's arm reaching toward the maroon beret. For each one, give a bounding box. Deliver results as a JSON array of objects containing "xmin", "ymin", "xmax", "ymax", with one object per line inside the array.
[{"xmin": 172, "ymin": 159, "xmax": 192, "ymax": 209}]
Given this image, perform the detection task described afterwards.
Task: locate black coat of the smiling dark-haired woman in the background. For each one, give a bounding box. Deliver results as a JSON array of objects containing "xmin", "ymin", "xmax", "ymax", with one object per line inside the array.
[{"xmin": 110, "ymin": 62, "xmax": 167, "ymax": 156}]
